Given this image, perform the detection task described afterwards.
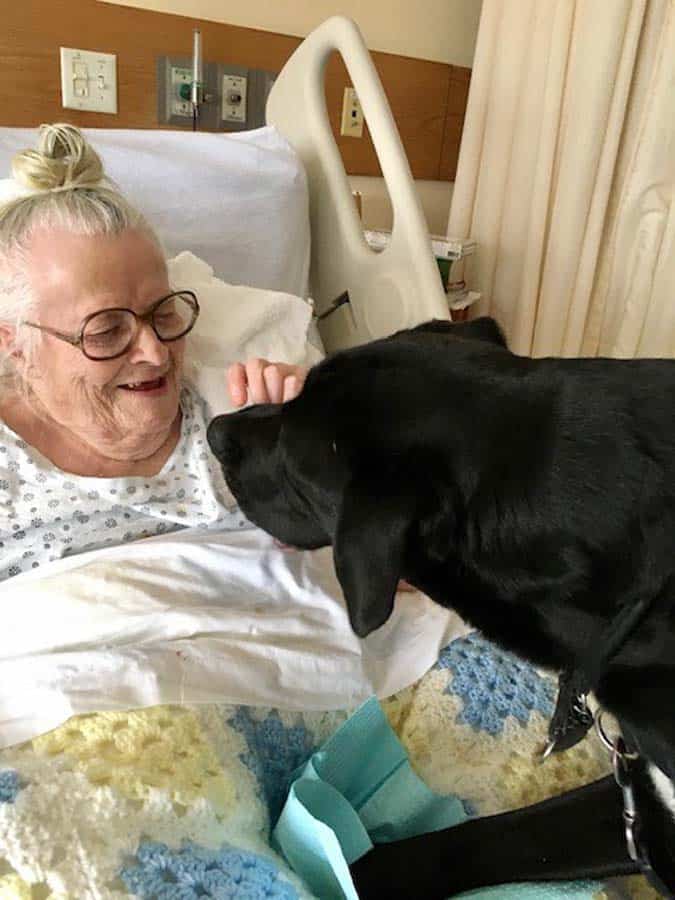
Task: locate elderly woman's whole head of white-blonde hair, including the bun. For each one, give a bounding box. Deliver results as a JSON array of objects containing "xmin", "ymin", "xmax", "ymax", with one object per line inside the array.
[{"xmin": 0, "ymin": 124, "xmax": 160, "ymax": 374}]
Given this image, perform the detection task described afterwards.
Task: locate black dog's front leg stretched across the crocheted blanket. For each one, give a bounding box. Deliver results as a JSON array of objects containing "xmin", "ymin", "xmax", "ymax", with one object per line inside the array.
[{"xmin": 351, "ymin": 776, "xmax": 638, "ymax": 900}]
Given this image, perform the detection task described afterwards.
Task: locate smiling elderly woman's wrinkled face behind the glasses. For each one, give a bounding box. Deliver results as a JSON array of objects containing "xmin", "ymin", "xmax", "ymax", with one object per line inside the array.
[{"xmin": 20, "ymin": 229, "xmax": 185, "ymax": 459}]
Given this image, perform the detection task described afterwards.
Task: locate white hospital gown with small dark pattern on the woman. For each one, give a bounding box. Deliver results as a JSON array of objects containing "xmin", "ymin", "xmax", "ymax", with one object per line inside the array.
[{"xmin": 0, "ymin": 386, "xmax": 252, "ymax": 581}]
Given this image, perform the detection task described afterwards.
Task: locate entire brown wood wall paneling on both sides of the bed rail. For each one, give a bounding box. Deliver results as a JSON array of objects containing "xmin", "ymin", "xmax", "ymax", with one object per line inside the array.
[{"xmin": 0, "ymin": 0, "xmax": 470, "ymax": 180}]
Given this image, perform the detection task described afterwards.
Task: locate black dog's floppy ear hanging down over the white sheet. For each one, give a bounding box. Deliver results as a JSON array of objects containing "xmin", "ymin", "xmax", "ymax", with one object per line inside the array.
[{"xmin": 333, "ymin": 477, "xmax": 415, "ymax": 637}]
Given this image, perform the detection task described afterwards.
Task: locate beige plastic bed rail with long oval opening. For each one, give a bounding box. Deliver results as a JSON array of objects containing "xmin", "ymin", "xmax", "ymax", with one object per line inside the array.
[{"xmin": 266, "ymin": 16, "xmax": 449, "ymax": 350}]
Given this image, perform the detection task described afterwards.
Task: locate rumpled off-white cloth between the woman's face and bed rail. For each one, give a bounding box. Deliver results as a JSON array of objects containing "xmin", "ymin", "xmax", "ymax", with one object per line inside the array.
[{"xmin": 172, "ymin": 252, "xmax": 321, "ymax": 415}]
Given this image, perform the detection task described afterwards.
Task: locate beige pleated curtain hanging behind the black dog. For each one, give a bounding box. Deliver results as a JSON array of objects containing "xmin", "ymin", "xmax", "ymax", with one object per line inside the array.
[{"xmin": 448, "ymin": 0, "xmax": 675, "ymax": 356}]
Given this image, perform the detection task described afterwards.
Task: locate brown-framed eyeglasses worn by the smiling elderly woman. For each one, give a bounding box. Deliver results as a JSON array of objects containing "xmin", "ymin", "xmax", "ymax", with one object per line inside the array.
[{"xmin": 22, "ymin": 291, "xmax": 199, "ymax": 361}]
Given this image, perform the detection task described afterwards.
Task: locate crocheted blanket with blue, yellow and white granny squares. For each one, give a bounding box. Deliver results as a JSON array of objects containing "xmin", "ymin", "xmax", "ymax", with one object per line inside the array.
[{"xmin": 0, "ymin": 634, "xmax": 657, "ymax": 900}]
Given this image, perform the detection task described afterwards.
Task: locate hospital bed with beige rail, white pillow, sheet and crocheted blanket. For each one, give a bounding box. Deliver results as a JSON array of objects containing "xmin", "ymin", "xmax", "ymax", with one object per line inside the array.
[{"xmin": 0, "ymin": 17, "xmax": 632, "ymax": 900}]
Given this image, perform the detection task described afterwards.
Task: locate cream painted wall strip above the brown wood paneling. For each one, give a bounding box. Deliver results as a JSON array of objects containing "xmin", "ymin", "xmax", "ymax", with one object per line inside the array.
[{"xmin": 104, "ymin": 0, "xmax": 481, "ymax": 68}]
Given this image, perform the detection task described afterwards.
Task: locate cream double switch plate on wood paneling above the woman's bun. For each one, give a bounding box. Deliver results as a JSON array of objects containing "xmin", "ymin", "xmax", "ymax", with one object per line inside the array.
[{"xmin": 61, "ymin": 47, "xmax": 117, "ymax": 114}]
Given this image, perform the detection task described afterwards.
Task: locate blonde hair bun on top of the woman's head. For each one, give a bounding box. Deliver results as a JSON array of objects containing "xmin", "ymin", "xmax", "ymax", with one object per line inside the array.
[{"xmin": 12, "ymin": 123, "xmax": 103, "ymax": 191}]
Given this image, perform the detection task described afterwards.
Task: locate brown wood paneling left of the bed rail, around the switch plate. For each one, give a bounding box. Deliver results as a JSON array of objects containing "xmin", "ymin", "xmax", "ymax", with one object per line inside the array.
[{"xmin": 0, "ymin": 0, "xmax": 300, "ymax": 128}]
